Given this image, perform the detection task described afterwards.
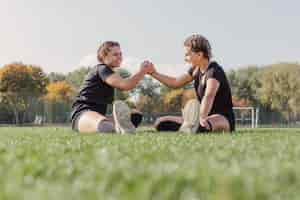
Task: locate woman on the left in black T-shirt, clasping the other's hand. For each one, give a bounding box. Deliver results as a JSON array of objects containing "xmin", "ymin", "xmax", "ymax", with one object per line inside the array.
[{"xmin": 71, "ymin": 41, "xmax": 152, "ymax": 133}]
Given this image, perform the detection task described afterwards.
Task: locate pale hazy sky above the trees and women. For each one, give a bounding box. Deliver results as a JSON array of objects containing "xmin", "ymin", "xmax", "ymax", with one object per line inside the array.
[{"xmin": 0, "ymin": 0, "xmax": 300, "ymax": 74}]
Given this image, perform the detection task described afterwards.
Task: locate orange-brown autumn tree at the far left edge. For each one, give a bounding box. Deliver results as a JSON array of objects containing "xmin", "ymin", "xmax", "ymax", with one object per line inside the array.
[{"xmin": 0, "ymin": 63, "xmax": 48, "ymax": 124}]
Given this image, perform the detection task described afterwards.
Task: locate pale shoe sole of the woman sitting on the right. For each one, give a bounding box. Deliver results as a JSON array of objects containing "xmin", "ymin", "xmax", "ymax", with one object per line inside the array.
[{"xmin": 179, "ymin": 99, "xmax": 200, "ymax": 133}]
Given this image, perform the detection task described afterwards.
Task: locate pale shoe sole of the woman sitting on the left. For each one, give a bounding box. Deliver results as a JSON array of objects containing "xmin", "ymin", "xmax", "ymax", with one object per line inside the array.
[{"xmin": 113, "ymin": 101, "xmax": 135, "ymax": 134}]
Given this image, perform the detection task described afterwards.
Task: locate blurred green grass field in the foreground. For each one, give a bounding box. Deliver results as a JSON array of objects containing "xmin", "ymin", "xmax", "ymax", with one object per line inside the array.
[{"xmin": 0, "ymin": 128, "xmax": 300, "ymax": 200}]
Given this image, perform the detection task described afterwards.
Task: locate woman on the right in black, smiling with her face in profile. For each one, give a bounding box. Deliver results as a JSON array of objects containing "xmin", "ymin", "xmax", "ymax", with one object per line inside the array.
[{"xmin": 151, "ymin": 35, "xmax": 235, "ymax": 132}]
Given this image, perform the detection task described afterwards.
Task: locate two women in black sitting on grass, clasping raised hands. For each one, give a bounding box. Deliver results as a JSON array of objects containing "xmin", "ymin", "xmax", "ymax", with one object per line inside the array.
[{"xmin": 72, "ymin": 35, "xmax": 235, "ymax": 133}]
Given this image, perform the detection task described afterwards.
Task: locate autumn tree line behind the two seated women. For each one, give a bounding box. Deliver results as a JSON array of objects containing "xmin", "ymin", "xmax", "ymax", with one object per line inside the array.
[{"xmin": 0, "ymin": 63, "xmax": 300, "ymax": 124}]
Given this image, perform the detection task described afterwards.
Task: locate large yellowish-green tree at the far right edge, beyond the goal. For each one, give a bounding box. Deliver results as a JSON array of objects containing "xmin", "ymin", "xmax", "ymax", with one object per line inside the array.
[{"xmin": 259, "ymin": 63, "xmax": 300, "ymax": 122}]
